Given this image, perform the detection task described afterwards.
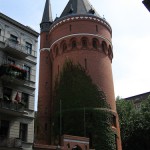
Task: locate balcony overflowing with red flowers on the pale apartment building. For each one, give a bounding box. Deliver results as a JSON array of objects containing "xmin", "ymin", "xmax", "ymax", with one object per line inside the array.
[{"xmin": 0, "ymin": 64, "xmax": 27, "ymax": 82}]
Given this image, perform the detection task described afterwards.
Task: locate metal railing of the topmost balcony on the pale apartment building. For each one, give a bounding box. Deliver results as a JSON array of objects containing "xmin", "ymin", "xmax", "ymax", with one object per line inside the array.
[{"xmin": 0, "ymin": 35, "xmax": 37, "ymax": 57}]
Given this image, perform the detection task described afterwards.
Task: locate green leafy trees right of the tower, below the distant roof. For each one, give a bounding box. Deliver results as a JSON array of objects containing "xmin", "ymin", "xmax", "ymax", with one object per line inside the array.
[{"xmin": 117, "ymin": 98, "xmax": 150, "ymax": 150}]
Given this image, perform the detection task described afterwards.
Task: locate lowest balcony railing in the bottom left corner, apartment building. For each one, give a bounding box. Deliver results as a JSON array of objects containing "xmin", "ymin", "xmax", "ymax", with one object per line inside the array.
[{"xmin": 0, "ymin": 136, "xmax": 22, "ymax": 149}]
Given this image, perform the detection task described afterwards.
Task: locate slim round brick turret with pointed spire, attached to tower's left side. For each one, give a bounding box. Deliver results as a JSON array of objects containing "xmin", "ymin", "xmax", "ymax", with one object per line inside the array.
[{"xmin": 36, "ymin": 0, "xmax": 53, "ymax": 145}]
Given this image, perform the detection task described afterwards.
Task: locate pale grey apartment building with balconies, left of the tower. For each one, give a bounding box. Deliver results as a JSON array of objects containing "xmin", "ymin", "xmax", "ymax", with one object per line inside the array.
[{"xmin": 0, "ymin": 13, "xmax": 39, "ymax": 150}]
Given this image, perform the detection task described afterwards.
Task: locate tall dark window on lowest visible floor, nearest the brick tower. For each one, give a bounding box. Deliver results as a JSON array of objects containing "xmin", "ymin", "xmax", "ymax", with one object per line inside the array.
[{"xmin": 19, "ymin": 123, "xmax": 28, "ymax": 142}]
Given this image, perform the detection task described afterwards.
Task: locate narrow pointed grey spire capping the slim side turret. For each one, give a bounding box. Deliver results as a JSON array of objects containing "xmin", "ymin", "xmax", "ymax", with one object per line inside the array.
[{"xmin": 41, "ymin": 0, "xmax": 53, "ymax": 23}]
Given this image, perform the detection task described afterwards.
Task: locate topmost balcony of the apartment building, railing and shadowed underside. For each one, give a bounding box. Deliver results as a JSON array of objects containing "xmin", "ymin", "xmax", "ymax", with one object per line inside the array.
[{"xmin": 0, "ymin": 36, "xmax": 37, "ymax": 58}]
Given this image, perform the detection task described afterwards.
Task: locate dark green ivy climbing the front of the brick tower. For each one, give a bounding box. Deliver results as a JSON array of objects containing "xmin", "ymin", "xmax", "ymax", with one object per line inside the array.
[{"xmin": 54, "ymin": 61, "xmax": 116, "ymax": 150}]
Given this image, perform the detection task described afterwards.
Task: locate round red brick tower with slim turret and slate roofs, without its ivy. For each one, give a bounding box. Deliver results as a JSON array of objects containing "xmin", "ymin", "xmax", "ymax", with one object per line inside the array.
[{"xmin": 37, "ymin": 0, "xmax": 121, "ymax": 150}]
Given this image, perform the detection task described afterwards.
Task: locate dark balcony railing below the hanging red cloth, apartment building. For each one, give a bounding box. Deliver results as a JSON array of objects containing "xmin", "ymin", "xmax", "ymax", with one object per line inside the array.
[{"xmin": 0, "ymin": 99, "xmax": 25, "ymax": 112}]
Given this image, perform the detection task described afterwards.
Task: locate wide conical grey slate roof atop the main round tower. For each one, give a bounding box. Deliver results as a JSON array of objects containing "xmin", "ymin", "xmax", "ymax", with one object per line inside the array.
[{"xmin": 60, "ymin": 0, "xmax": 100, "ymax": 18}]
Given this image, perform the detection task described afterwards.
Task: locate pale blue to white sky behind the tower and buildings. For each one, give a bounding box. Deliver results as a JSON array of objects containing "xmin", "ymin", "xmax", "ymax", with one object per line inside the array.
[{"xmin": 0, "ymin": 0, "xmax": 150, "ymax": 102}]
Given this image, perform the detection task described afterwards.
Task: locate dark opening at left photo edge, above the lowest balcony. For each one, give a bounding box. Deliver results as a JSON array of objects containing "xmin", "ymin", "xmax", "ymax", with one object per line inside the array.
[{"xmin": 0, "ymin": 120, "xmax": 9, "ymax": 140}]
